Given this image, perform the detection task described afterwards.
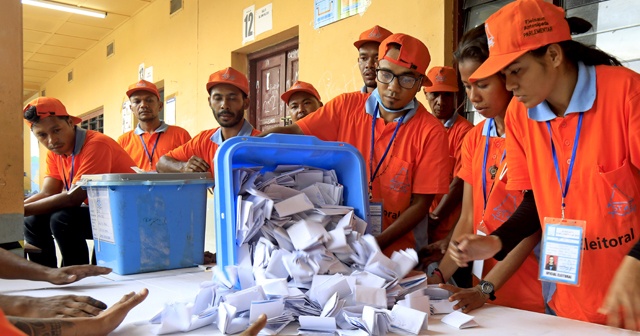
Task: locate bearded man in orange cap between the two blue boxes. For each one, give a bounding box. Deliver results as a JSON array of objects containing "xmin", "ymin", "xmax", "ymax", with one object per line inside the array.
[{"xmin": 157, "ymin": 67, "xmax": 260, "ymax": 175}]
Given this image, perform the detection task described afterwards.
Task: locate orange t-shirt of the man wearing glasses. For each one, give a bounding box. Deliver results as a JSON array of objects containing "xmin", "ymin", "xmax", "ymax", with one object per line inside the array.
[{"xmin": 297, "ymin": 92, "xmax": 451, "ymax": 255}]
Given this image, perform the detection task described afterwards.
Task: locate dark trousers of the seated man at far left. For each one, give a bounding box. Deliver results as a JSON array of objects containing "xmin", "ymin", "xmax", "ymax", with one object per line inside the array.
[{"xmin": 24, "ymin": 207, "xmax": 93, "ymax": 268}]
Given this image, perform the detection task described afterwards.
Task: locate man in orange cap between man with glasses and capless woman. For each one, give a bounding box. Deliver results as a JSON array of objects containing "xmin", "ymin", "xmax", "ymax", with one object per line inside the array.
[{"xmin": 414, "ymin": 66, "xmax": 473, "ymax": 252}]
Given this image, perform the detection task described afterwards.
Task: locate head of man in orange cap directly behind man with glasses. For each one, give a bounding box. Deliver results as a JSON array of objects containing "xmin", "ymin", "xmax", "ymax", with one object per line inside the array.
[{"xmin": 353, "ymin": 26, "xmax": 391, "ymax": 93}]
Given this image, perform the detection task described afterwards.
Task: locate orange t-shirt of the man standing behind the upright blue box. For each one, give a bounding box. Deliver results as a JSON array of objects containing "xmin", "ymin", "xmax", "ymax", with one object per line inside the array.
[{"xmin": 118, "ymin": 122, "xmax": 191, "ymax": 171}]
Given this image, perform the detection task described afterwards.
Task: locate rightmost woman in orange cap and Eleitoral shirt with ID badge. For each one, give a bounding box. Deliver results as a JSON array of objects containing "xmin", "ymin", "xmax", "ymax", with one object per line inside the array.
[{"xmin": 449, "ymin": 0, "xmax": 640, "ymax": 329}]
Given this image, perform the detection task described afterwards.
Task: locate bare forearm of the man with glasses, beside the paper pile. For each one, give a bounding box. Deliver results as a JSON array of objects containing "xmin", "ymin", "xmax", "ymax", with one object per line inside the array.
[{"xmin": 376, "ymin": 194, "xmax": 434, "ymax": 250}]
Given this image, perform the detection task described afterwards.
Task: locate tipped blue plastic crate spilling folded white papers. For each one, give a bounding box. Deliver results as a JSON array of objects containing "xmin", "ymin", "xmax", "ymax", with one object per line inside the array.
[{"xmin": 214, "ymin": 134, "xmax": 369, "ymax": 278}]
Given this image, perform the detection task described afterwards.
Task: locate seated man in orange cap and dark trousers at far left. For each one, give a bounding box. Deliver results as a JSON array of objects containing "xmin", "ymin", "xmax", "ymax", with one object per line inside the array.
[{"xmin": 23, "ymin": 97, "xmax": 135, "ymax": 267}]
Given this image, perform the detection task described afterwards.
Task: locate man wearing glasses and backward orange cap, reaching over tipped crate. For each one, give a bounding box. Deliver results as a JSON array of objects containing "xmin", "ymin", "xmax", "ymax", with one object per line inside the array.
[{"xmin": 261, "ymin": 34, "xmax": 451, "ymax": 255}]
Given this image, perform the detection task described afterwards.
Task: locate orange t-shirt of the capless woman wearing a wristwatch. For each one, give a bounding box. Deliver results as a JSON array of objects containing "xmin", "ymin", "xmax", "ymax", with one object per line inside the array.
[{"xmin": 458, "ymin": 120, "xmax": 544, "ymax": 313}]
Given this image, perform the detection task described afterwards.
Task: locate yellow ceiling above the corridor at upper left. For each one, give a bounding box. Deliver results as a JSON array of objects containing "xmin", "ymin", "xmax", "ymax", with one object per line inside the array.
[{"xmin": 22, "ymin": 0, "xmax": 155, "ymax": 100}]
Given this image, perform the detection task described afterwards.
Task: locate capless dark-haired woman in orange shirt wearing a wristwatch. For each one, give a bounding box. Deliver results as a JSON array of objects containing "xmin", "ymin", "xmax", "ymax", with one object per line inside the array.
[{"xmin": 429, "ymin": 26, "xmax": 544, "ymax": 313}]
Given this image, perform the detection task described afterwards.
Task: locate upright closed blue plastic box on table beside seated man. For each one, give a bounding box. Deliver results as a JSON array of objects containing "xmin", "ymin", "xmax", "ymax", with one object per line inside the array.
[{"xmin": 81, "ymin": 174, "xmax": 213, "ymax": 275}]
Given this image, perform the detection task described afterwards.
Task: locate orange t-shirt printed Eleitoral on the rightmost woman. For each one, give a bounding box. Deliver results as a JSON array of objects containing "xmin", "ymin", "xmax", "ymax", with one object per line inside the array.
[{"xmin": 506, "ymin": 64, "xmax": 640, "ymax": 323}]
